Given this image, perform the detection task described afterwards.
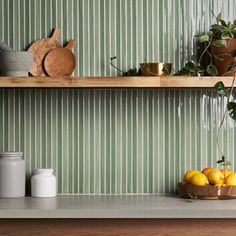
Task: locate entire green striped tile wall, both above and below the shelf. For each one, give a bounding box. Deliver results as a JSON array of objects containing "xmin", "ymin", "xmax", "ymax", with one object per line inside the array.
[{"xmin": 0, "ymin": 0, "xmax": 236, "ymax": 194}]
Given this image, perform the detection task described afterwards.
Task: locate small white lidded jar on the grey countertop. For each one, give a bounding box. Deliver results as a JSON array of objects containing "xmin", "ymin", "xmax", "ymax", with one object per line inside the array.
[{"xmin": 31, "ymin": 169, "xmax": 56, "ymax": 197}]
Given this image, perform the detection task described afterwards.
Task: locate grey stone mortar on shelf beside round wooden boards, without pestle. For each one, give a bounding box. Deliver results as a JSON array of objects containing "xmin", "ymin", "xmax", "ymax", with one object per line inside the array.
[{"xmin": 0, "ymin": 51, "xmax": 33, "ymax": 77}]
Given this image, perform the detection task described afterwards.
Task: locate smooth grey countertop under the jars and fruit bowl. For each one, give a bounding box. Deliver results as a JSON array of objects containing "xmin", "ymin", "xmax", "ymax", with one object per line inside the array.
[{"xmin": 0, "ymin": 195, "xmax": 236, "ymax": 219}]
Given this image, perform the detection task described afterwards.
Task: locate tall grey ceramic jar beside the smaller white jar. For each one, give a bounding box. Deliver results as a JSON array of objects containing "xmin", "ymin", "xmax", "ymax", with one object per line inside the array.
[{"xmin": 0, "ymin": 152, "xmax": 25, "ymax": 198}]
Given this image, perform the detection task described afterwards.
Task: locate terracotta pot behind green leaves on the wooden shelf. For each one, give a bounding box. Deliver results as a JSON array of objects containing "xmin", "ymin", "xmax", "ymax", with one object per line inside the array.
[{"xmin": 211, "ymin": 39, "xmax": 236, "ymax": 76}]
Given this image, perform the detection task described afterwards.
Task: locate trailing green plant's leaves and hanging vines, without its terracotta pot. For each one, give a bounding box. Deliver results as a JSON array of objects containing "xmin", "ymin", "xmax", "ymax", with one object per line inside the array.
[{"xmin": 174, "ymin": 13, "xmax": 236, "ymax": 164}]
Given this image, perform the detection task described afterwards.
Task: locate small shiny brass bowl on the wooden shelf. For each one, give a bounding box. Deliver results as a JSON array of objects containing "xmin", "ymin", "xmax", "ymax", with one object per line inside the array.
[{"xmin": 140, "ymin": 62, "xmax": 172, "ymax": 76}]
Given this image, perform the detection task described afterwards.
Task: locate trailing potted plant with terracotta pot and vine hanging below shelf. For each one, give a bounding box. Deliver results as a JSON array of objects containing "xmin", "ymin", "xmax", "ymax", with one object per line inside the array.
[{"xmin": 175, "ymin": 13, "xmax": 236, "ymax": 136}]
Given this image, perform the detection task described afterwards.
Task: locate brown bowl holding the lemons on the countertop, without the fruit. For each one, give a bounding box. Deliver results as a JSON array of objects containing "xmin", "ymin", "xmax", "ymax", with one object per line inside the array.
[{"xmin": 178, "ymin": 183, "xmax": 236, "ymax": 199}]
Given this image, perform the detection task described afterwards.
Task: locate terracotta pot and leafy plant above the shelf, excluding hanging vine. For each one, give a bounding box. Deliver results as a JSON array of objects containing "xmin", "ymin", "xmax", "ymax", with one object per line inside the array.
[{"xmin": 175, "ymin": 13, "xmax": 236, "ymax": 76}]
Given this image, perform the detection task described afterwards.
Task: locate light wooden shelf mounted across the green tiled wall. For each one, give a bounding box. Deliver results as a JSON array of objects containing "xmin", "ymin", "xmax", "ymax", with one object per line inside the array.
[{"xmin": 0, "ymin": 76, "xmax": 233, "ymax": 88}]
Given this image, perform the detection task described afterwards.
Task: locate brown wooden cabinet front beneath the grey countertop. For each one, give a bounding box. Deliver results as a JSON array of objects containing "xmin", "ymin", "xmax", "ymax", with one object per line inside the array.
[{"xmin": 0, "ymin": 219, "xmax": 236, "ymax": 236}]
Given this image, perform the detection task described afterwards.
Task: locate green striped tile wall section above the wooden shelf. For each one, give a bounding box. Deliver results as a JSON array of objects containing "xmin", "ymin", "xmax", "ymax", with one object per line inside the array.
[{"xmin": 0, "ymin": 0, "xmax": 236, "ymax": 76}]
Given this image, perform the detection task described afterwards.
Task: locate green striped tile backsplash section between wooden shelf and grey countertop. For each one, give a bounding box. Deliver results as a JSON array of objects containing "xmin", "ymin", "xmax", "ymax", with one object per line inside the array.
[{"xmin": 0, "ymin": 89, "xmax": 236, "ymax": 194}]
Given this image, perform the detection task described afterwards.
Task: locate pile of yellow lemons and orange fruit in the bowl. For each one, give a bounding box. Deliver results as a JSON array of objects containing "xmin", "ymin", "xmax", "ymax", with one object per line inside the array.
[{"xmin": 182, "ymin": 167, "xmax": 236, "ymax": 186}]
